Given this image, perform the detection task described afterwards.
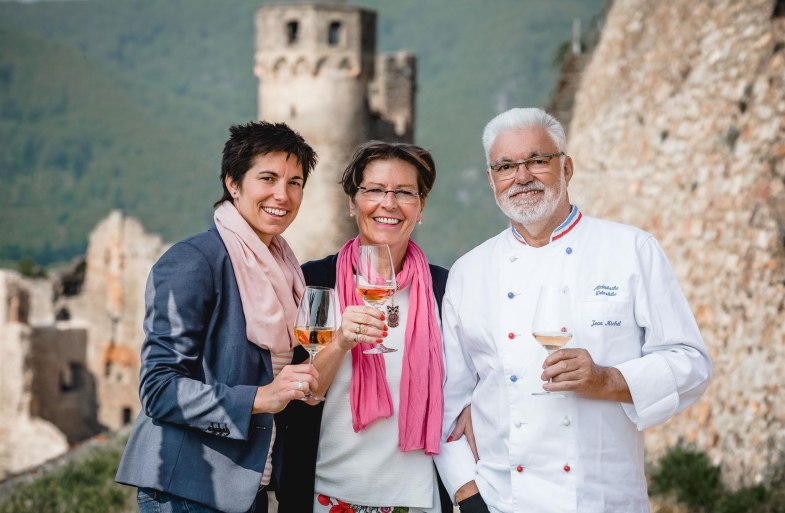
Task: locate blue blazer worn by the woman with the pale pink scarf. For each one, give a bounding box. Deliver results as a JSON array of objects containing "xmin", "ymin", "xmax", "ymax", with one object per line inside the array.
[{"xmin": 116, "ymin": 226, "xmax": 280, "ymax": 513}]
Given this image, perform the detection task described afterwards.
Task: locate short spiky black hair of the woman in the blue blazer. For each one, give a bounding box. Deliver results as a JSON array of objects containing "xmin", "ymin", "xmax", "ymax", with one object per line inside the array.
[{"xmin": 214, "ymin": 121, "xmax": 317, "ymax": 207}]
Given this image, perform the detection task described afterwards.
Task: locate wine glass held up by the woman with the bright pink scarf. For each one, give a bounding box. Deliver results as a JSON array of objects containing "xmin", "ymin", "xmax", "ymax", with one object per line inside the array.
[{"xmin": 355, "ymin": 244, "xmax": 397, "ymax": 354}]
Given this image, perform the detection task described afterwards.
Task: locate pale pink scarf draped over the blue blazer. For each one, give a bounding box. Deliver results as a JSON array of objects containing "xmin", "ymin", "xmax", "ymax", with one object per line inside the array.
[{"xmin": 213, "ymin": 201, "xmax": 305, "ymax": 354}]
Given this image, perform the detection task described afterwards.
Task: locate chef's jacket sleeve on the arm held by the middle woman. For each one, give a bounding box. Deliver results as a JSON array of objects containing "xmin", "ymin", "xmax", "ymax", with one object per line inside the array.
[{"xmin": 434, "ymin": 273, "xmax": 477, "ymax": 502}]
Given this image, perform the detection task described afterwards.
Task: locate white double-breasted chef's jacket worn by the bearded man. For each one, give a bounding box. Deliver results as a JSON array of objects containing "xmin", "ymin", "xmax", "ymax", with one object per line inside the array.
[{"xmin": 435, "ymin": 216, "xmax": 711, "ymax": 513}]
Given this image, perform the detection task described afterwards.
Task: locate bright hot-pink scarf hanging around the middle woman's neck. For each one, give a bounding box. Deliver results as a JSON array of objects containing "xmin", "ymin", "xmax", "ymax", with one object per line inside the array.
[{"xmin": 336, "ymin": 237, "xmax": 444, "ymax": 455}]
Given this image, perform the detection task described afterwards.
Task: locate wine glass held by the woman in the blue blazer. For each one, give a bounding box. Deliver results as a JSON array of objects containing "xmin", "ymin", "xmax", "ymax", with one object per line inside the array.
[{"xmin": 294, "ymin": 287, "xmax": 338, "ymax": 401}]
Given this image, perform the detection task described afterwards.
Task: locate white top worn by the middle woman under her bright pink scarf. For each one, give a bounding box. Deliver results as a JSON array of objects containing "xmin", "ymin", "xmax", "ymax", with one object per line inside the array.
[{"xmin": 315, "ymin": 287, "xmax": 438, "ymax": 508}]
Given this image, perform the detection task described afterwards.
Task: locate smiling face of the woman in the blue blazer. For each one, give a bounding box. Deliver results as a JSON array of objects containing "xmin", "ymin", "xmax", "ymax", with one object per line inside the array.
[{"xmin": 225, "ymin": 151, "xmax": 304, "ymax": 245}]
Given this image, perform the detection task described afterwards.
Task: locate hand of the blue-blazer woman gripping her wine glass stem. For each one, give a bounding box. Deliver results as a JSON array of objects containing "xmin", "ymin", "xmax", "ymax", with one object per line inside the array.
[{"xmin": 251, "ymin": 363, "xmax": 319, "ymax": 413}]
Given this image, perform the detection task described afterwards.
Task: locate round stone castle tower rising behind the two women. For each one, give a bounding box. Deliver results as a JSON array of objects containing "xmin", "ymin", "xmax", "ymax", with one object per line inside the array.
[{"xmin": 255, "ymin": 3, "xmax": 416, "ymax": 261}]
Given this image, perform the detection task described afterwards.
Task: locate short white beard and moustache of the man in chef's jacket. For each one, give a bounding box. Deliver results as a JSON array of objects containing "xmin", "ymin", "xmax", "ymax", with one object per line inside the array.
[{"xmin": 493, "ymin": 170, "xmax": 567, "ymax": 226}]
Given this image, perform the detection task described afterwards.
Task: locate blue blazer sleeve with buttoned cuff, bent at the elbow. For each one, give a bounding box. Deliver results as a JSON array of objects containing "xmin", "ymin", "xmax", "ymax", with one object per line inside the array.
[{"xmin": 139, "ymin": 242, "xmax": 257, "ymax": 440}]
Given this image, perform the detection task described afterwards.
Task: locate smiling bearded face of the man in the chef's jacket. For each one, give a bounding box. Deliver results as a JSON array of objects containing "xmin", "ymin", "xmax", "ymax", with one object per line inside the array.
[{"xmin": 488, "ymin": 126, "xmax": 572, "ymax": 228}]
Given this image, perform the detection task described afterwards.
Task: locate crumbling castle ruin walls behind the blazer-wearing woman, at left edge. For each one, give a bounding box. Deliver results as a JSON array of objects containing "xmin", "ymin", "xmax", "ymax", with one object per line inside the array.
[{"xmin": 0, "ymin": 212, "xmax": 165, "ymax": 479}]
